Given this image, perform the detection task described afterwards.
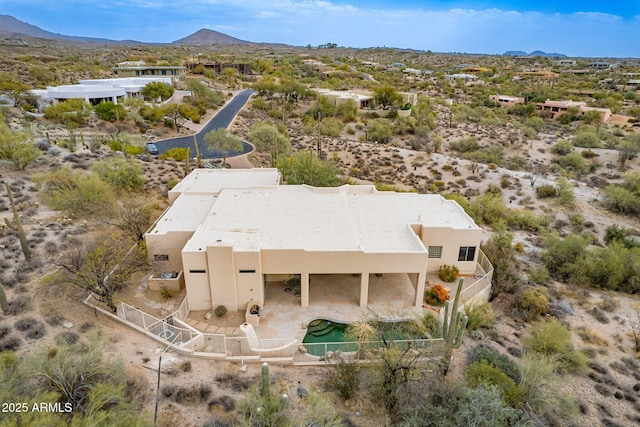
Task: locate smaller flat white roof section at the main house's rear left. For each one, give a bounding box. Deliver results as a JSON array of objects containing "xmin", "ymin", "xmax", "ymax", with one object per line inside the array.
[{"xmin": 169, "ymin": 168, "xmax": 280, "ymax": 202}]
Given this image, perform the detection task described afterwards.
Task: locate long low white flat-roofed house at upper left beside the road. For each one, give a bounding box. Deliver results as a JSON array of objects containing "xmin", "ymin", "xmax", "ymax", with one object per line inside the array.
[{"xmin": 31, "ymin": 77, "xmax": 172, "ymax": 108}]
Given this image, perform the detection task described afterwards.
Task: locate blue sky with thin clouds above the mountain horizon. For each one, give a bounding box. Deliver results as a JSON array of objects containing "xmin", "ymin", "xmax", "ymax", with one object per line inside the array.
[{"xmin": 0, "ymin": 0, "xmax": 640, "ymax": 57}]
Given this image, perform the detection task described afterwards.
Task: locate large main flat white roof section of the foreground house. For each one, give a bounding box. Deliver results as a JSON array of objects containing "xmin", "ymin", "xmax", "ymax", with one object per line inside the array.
[{"xmin": 184, "ymin": 185, "xmax": 478, "ymax": 253}]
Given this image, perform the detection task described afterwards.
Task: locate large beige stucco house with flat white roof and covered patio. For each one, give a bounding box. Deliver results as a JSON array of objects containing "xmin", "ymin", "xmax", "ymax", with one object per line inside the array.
[{"xmin": 145, "ymin": 169, "xmax": 482, "ymax": 316}]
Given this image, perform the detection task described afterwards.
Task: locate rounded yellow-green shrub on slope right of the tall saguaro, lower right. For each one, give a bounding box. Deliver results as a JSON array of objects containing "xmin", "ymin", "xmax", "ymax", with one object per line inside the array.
[{"xmin": 522, "ymin": 319, "xmax": 587, "ymax": 372}]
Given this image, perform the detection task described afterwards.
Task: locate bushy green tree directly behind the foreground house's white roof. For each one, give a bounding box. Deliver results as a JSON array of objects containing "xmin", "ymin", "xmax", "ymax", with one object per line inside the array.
[{"xmin": 277, "ymin": 151, "xmax": 340, "ymax": 187}]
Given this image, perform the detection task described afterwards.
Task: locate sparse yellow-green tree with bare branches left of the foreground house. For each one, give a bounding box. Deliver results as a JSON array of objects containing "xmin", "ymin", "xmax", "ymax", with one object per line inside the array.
[{"xmin": 52, "ymin": 233, "xmax": 149, "ymax": 313}]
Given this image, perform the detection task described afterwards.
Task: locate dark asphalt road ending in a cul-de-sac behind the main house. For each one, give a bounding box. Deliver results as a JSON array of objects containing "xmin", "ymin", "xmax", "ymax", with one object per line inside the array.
[{"xmin": 154, "ymin": 89, "xmax": 254, "ymax": 159}]
